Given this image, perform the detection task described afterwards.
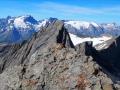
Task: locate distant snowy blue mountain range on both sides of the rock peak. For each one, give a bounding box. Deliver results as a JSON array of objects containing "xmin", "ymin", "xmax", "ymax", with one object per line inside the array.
[{"xmin": 0, "ymin": 15, "xmax": 120, "ymax": 44}]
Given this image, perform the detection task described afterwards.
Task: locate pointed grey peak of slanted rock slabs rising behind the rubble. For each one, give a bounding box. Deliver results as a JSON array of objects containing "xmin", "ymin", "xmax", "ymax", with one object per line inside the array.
[{"xmin": 0, "ymin": 21, "xmax": 74, "ymax": 69}]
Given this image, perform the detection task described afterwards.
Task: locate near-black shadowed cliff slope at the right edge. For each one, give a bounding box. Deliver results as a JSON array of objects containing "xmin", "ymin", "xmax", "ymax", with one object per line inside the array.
[{"xmin": 91, "ymin": 37, "xmax": 120, "ymax": 79}]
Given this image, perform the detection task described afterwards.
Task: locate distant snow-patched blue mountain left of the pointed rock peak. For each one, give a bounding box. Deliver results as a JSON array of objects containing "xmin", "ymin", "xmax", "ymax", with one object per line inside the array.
[{"xmin": 0, "ymin": 15, "xmax": 47, "ymax": 43}]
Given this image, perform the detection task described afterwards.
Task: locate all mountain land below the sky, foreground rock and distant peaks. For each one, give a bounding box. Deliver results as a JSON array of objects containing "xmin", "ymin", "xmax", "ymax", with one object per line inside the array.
[{"xmin": 0, "ymin": 15, "xmax": 120, "ymax": 90}]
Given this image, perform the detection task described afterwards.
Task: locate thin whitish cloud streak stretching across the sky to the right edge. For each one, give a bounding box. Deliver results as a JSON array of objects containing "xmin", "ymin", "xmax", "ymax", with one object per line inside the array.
[{"xmin": 38, "ymin": 2, "xmax": 120, "ymax": 15}]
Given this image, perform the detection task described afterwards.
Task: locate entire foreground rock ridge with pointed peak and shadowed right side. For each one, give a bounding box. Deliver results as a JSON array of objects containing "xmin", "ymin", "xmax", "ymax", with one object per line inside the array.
[{"xmin": 0, "ymin": 20, "xmax": 120, "ymax": 90}]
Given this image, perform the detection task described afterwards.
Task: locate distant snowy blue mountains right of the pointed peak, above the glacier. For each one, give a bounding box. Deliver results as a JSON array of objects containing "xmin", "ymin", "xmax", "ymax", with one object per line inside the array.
[{"xmin": 65, "ymin": 21, "xmax": 120, "ymax": 37}]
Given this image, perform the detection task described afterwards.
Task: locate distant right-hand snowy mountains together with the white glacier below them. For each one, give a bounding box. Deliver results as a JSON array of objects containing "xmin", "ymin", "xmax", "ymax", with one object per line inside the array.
[{"xmin": 65, "ymin": 21, "xmax": 120, "ymax": 49}]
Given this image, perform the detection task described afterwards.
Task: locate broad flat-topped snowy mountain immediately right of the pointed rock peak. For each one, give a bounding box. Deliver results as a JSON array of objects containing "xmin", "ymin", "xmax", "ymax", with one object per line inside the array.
[{"xmin": 65, "ymin": 21, "xmax": 104, "ymax": 37}]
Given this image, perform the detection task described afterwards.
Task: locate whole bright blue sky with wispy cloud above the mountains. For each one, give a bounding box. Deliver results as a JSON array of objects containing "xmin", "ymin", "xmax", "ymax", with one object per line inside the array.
[{"xmin": 0, "ymin": 0, "xmax": 120, "ymax": 24}]
